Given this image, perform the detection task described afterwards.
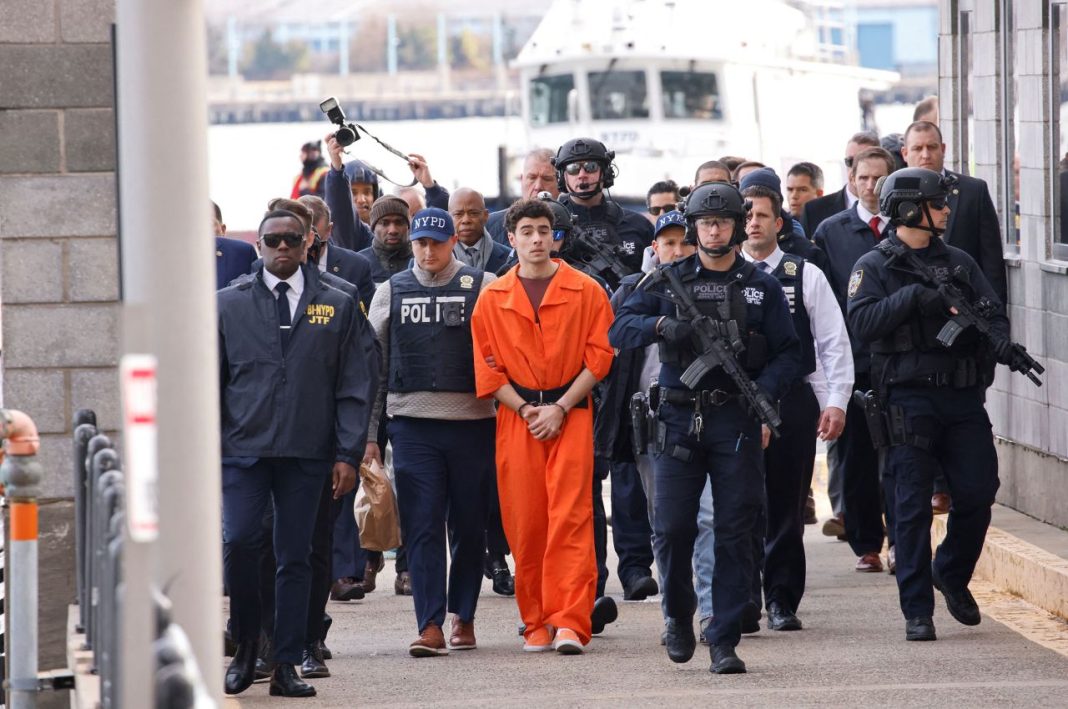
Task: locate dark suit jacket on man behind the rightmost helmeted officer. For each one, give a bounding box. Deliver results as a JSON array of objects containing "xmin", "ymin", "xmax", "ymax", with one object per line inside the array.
[{"xmin": 942, "ymin": 171, "xmax": 1008, "ymax": 303}]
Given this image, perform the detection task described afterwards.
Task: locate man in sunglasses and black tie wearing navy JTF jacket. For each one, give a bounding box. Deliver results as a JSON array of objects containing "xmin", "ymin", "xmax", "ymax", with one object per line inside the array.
[{"xmin": 218, "ymin": 210, "xmax": 374, "ymax": 696}]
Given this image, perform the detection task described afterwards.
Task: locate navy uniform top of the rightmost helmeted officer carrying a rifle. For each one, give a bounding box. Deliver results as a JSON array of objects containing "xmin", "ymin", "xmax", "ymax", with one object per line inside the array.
[{"xmin": 847, "ymin": 234, "xmax": 1009, "ymax": 388}]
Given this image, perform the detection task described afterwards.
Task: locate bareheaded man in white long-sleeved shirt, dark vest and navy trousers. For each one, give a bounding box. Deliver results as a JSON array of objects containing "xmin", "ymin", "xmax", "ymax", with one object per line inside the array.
[{"xmin": 742, "ymin": 183, "xmax": 853, "ymax": 630}]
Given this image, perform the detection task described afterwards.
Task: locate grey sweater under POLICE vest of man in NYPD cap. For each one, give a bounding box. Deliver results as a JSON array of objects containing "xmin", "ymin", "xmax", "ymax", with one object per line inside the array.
[{"xmin": 367, "ymin": 256, "xmax": 497, "ymax": 441}]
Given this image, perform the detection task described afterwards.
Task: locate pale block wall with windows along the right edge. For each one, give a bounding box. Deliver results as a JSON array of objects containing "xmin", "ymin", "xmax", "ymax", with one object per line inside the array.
[{"xmin": 939, "ymin": 0, "xmax": 1068, "ymax": 526}]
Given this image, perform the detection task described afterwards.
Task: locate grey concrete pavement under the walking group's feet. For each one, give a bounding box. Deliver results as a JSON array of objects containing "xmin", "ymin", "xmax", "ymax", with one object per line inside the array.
[{"xmin": 225, "ymin": 493, "xmax": 1068, "ymax": 708}]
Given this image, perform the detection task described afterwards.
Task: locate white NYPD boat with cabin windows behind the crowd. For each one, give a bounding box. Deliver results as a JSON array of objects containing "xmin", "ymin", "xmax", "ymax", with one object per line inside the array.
[{"xmin": 514, "ymin": 0, "xmax": 897, "ymax": 198}]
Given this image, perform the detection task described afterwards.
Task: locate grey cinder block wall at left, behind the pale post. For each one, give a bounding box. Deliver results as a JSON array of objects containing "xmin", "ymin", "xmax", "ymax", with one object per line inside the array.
[{"xmin": 0, "ymin": 0, "xmax": 119, "ymax": 498}]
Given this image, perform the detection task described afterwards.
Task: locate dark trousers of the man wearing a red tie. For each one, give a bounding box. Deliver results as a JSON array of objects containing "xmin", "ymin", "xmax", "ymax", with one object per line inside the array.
[{"xmin": 836, "ymin": 372, "xmax": 884, "ymax": 556}]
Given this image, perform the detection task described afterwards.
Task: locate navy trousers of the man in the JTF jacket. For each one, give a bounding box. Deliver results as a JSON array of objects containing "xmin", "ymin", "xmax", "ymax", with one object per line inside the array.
[{"xmin": 222, "ymin": 458, "xmax": 332, "ymax": 664}]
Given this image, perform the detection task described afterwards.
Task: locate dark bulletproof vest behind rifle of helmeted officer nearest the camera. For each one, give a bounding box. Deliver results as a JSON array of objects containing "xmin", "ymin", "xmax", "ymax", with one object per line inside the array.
[{"xmin": 659, "ymin": 263, "xmax": 768, "ymax": 372}]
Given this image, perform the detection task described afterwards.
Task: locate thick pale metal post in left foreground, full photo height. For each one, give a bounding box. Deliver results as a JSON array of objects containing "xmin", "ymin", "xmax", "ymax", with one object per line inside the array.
[{"xmin": 115, "ymin": 0, "xmax": 225, "ymax": 708}]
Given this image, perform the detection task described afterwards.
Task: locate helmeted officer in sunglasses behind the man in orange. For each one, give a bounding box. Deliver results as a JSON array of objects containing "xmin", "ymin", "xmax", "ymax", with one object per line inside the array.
[{"xmin": 552, "ymin": 138, "xmax": 653, "ymax": 288}]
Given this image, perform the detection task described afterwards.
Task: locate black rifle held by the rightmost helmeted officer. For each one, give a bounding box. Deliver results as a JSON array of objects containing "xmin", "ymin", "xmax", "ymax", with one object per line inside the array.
[{"xmin": 877, "ymin": 240, "xmax": 1046, "ymax": 387}]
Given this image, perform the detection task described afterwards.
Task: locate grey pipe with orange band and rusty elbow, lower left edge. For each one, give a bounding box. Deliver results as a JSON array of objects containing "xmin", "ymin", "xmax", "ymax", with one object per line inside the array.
[{"xmin": 0, "ymin": 409, "xmax": 41, "ymax": 709}]
